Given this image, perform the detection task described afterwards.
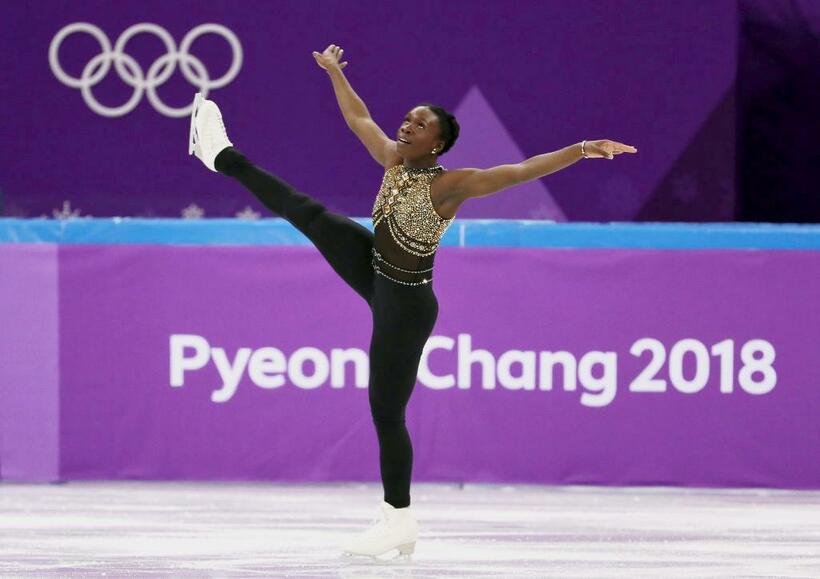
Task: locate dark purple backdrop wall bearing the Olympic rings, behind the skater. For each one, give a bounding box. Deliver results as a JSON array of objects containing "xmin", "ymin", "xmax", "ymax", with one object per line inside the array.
[{"xmin": 0, "ymin": 0, "xmax": 737, "ymax": 221}]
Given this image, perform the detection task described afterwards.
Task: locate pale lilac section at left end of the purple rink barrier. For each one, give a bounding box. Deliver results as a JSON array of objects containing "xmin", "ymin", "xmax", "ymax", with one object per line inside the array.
[{"xmin": 0, "ymin": 244, "xmax": 60, "ymax": 481}]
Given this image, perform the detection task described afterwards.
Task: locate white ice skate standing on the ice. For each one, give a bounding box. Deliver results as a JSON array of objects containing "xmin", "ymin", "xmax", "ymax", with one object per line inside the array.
[{"xmin": 343, "ymin": 502, "xmax": 419, "ymax": 560}]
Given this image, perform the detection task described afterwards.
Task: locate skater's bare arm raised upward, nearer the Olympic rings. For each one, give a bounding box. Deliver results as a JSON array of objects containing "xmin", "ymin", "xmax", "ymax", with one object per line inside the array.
[{"xmin": 313, "ymin": 44, "xmax": 401, "ymax": 167}]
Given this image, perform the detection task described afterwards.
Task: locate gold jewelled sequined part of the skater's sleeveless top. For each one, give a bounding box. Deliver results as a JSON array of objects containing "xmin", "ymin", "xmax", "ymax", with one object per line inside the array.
[{"xmin": 372, "ymin": 165, "xmax": 455, "ymax": 257}]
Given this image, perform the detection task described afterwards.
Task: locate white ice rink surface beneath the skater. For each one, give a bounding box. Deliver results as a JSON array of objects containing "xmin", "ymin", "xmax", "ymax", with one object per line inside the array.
[{"xmin": 0, "ymin": 482, "xmax": 820, "ymax": 578}]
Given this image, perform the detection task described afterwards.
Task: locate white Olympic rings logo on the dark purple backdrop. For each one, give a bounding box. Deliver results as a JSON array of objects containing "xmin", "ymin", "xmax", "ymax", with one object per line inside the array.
[{"xmin": 48, "ymin": 22, "xmax": 242, "ymax": 117}]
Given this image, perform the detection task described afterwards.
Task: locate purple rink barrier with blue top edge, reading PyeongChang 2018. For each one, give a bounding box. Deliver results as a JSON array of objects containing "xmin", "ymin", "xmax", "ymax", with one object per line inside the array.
[{"xmin": 0, "ymin": 219, "xmax": 820, "ymax": 488}]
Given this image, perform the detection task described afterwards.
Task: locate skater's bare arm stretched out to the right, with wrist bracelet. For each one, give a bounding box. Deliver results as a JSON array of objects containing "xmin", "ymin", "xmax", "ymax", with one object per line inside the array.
[{"xmin": 451, "ymin": 139, "xmax": 638, "ymax": 201}]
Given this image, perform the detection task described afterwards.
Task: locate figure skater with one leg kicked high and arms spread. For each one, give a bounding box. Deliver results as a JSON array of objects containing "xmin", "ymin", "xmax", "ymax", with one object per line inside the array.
[{"xmin": 188, "ymin": 44, "xmax": 637, "ymax": 556}]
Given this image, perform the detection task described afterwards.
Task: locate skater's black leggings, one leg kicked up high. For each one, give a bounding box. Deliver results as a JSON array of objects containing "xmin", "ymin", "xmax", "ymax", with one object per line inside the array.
[{"xmin": 216, "ymin": 147, "xmax": 438, "ymax": 508}]
